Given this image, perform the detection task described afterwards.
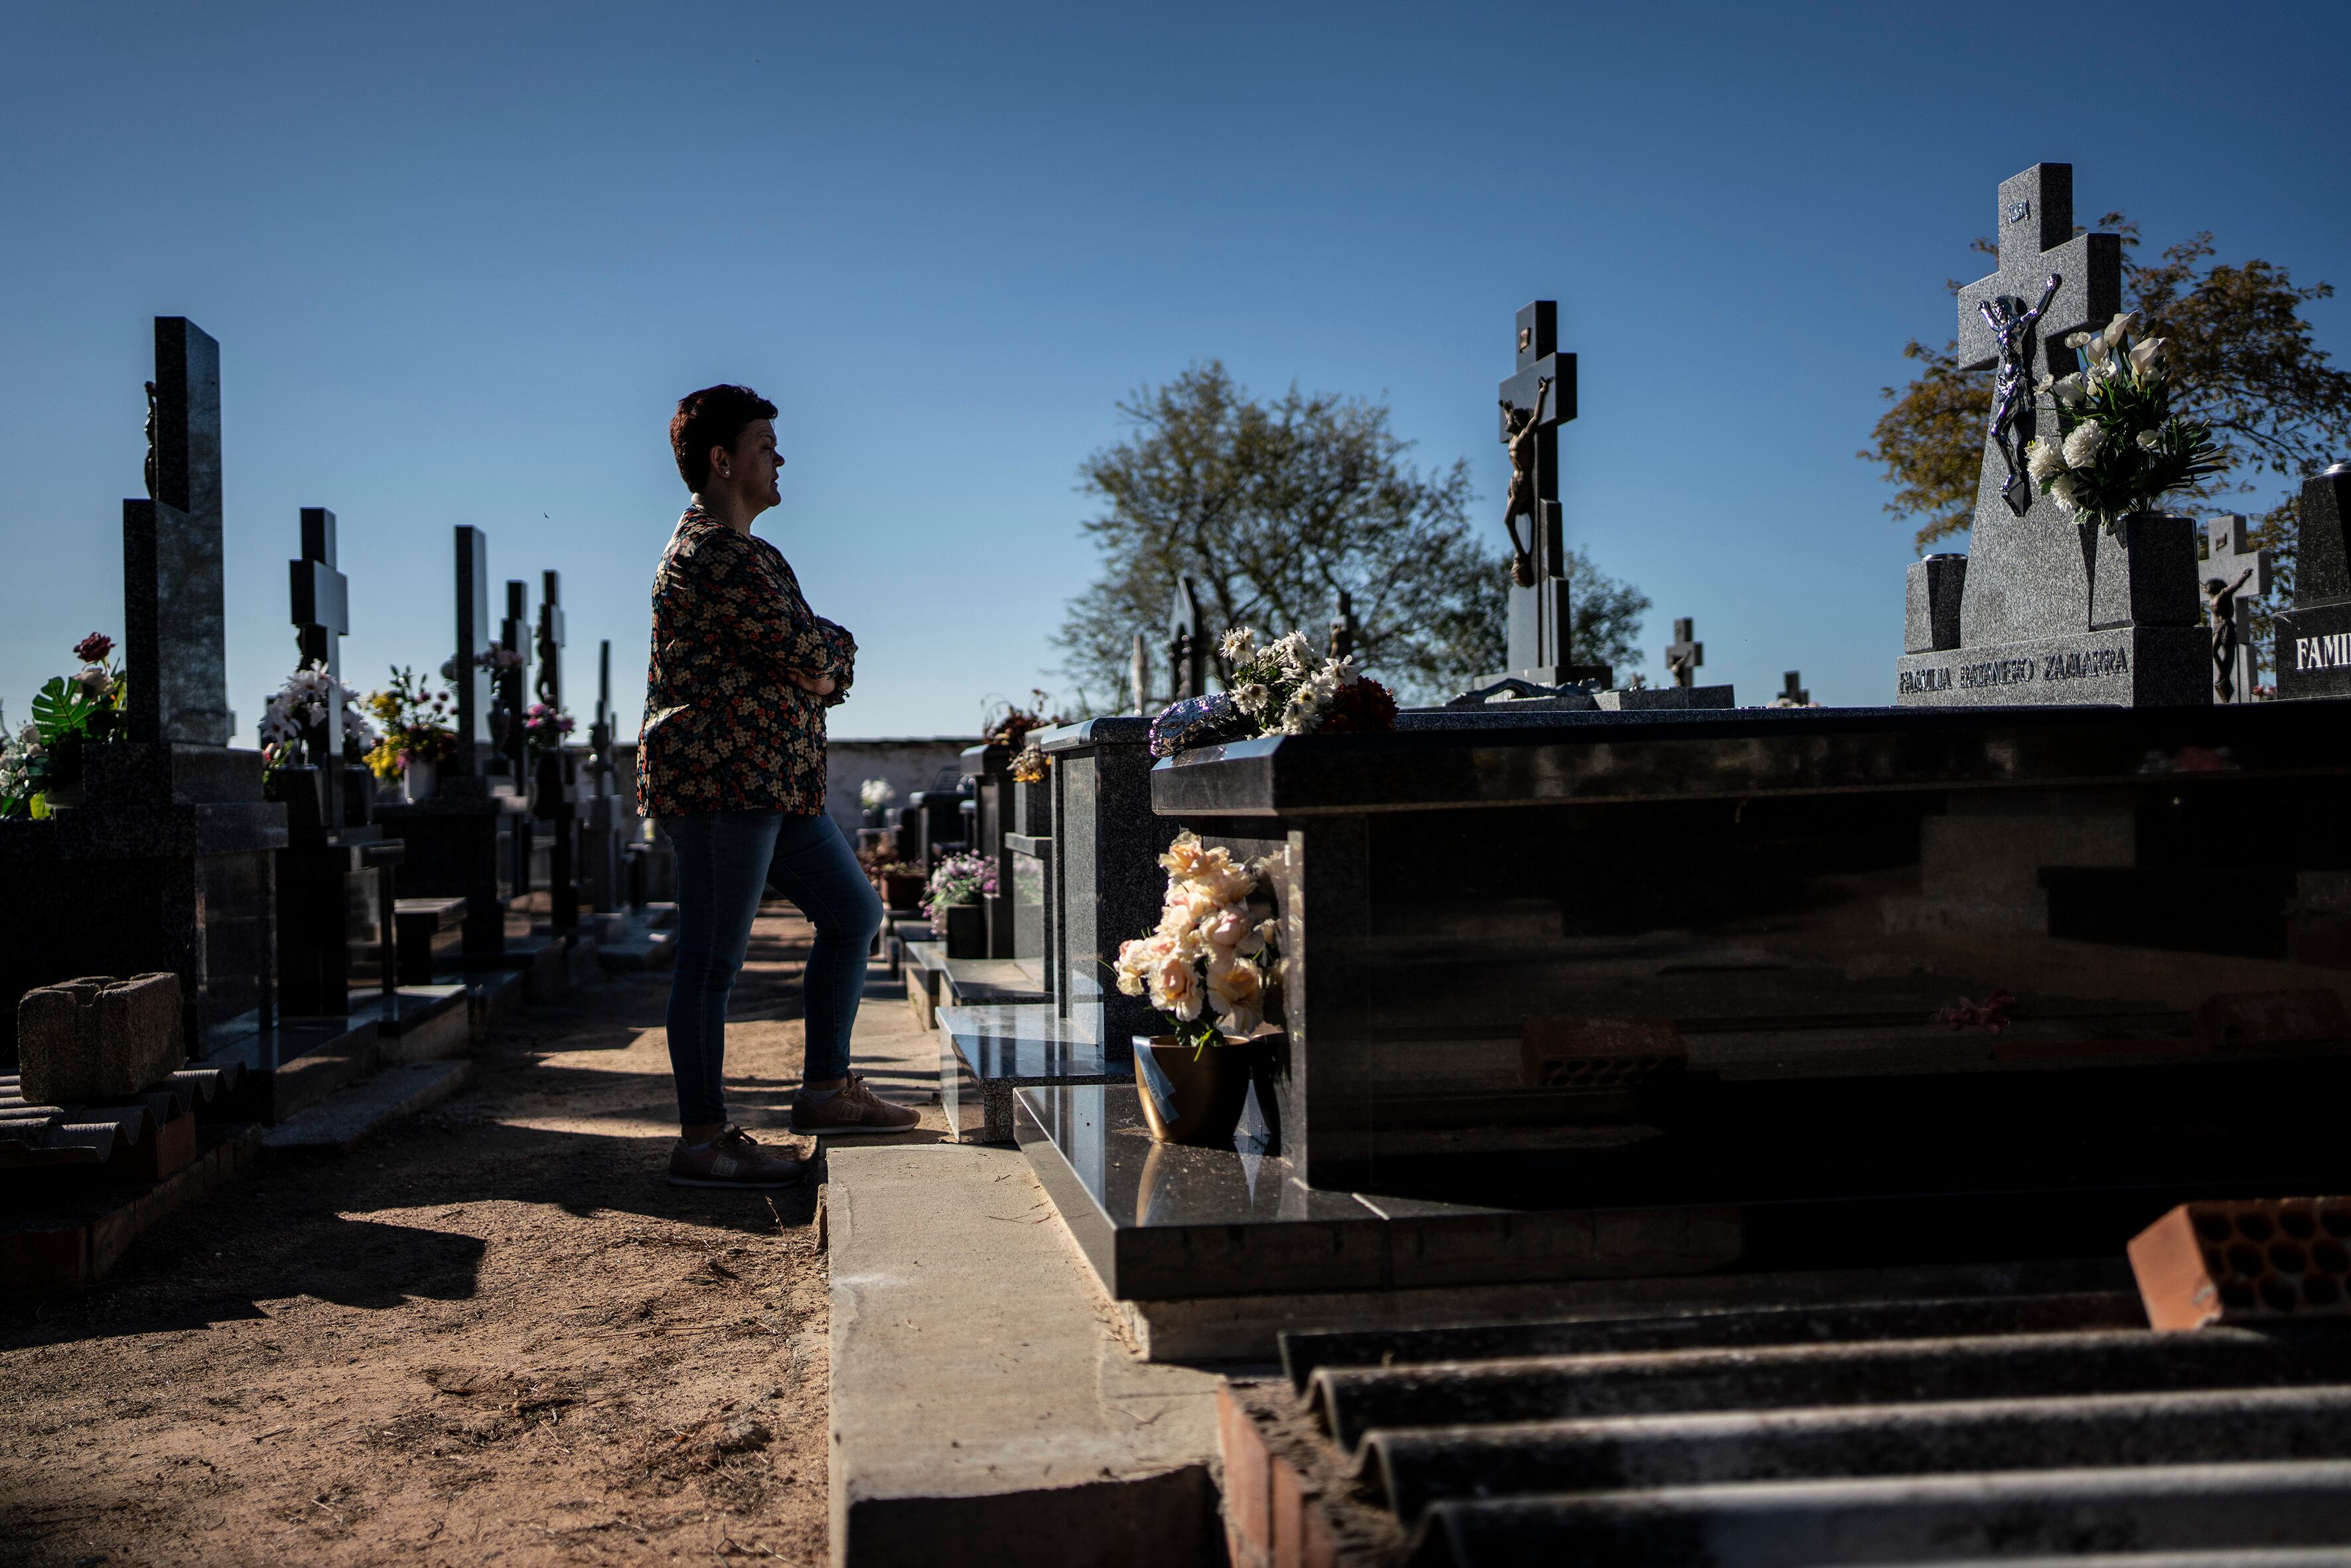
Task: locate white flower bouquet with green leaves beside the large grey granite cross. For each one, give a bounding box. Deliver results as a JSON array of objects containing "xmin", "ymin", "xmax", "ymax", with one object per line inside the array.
[{"xmin": 2025, "ymin": 313, "xmax": 2224, "ymax": 527}]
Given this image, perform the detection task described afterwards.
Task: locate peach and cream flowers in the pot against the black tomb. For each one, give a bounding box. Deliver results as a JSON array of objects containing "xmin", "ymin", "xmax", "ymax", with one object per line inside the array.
[{"xmin": 1117, "ymin": 832, "xmax": 1277, "ymax": 1048}]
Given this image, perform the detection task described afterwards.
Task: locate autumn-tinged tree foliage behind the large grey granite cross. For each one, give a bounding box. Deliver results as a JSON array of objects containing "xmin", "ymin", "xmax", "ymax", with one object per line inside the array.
[{"xmin": 1860, "ymin": 212, "xmax": 2351, "ymax": 553}]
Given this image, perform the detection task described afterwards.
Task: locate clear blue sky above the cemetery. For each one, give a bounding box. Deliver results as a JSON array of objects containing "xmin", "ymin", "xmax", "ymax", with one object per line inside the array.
[{"xmin": 0, "ymin": 0, "xmax": 2351, "ymax": 743}]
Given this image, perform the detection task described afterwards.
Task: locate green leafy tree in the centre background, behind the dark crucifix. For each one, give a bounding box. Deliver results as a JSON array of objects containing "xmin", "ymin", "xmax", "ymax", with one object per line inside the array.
[{"xmin": 1056, "ymin": 360, "xmax": 1648, "ymax": 712}]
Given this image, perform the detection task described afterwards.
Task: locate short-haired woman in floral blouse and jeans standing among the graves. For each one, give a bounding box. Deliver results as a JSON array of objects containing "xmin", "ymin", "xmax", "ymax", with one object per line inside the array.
[{"xmin": 637, "ymin": 386, "xmax": 919, "ymax": 1187}]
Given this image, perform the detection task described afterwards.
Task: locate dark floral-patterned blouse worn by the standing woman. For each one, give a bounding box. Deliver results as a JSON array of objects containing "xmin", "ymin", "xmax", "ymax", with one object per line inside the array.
[{"xmin": 637, "ymin": 506, "xmax": 858, "ymax": 818}]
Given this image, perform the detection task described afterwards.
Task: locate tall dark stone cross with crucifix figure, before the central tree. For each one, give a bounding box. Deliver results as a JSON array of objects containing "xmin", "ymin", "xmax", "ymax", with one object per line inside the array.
[{"xmin": 1479, "ymin": 299, "xmax": 1608, "ymax": 686}]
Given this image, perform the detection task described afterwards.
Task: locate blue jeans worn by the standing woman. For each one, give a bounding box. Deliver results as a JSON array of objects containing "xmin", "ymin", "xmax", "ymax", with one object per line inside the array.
[{"xmin": 661, "ymin": 811, "xmax": 882, "ymax": 1126}]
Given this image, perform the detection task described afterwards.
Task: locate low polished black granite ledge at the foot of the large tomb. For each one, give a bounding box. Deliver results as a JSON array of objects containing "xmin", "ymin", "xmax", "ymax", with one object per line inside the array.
[{"xmin": 1013, "ymin": 1074, "xmax": 2351, "ymax": 1300}]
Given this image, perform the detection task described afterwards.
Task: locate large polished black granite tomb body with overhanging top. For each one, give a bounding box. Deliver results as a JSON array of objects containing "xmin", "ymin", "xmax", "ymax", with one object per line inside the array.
[{"xmin": 1152, "ymin": 703, "xmax": 2351, "ymax": 1184}]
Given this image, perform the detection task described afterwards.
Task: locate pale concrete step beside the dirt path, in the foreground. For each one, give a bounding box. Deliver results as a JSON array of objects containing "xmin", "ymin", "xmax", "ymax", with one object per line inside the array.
[{"xmin": 825, "ymin": 1145, "xmax": 1218, "ymax": 1568}]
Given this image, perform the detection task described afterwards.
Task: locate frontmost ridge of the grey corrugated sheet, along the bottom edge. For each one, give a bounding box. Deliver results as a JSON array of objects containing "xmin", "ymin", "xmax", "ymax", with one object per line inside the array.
[{"xmin": 1406, "ymin": 1460, "xmax": 2351, "ymax": 1568}]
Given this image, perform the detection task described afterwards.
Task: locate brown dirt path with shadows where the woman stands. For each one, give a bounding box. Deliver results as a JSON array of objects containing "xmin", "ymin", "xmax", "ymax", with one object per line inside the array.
[{"xmin": 0, "ymin": 907, "xmax": 846, "ymax": 1568}]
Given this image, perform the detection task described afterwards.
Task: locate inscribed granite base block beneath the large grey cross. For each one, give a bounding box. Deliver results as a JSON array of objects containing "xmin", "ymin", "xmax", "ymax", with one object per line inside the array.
[{"xmin": 1895, "ymin": 625, "xmax": 2212, "ymax": 707}]
